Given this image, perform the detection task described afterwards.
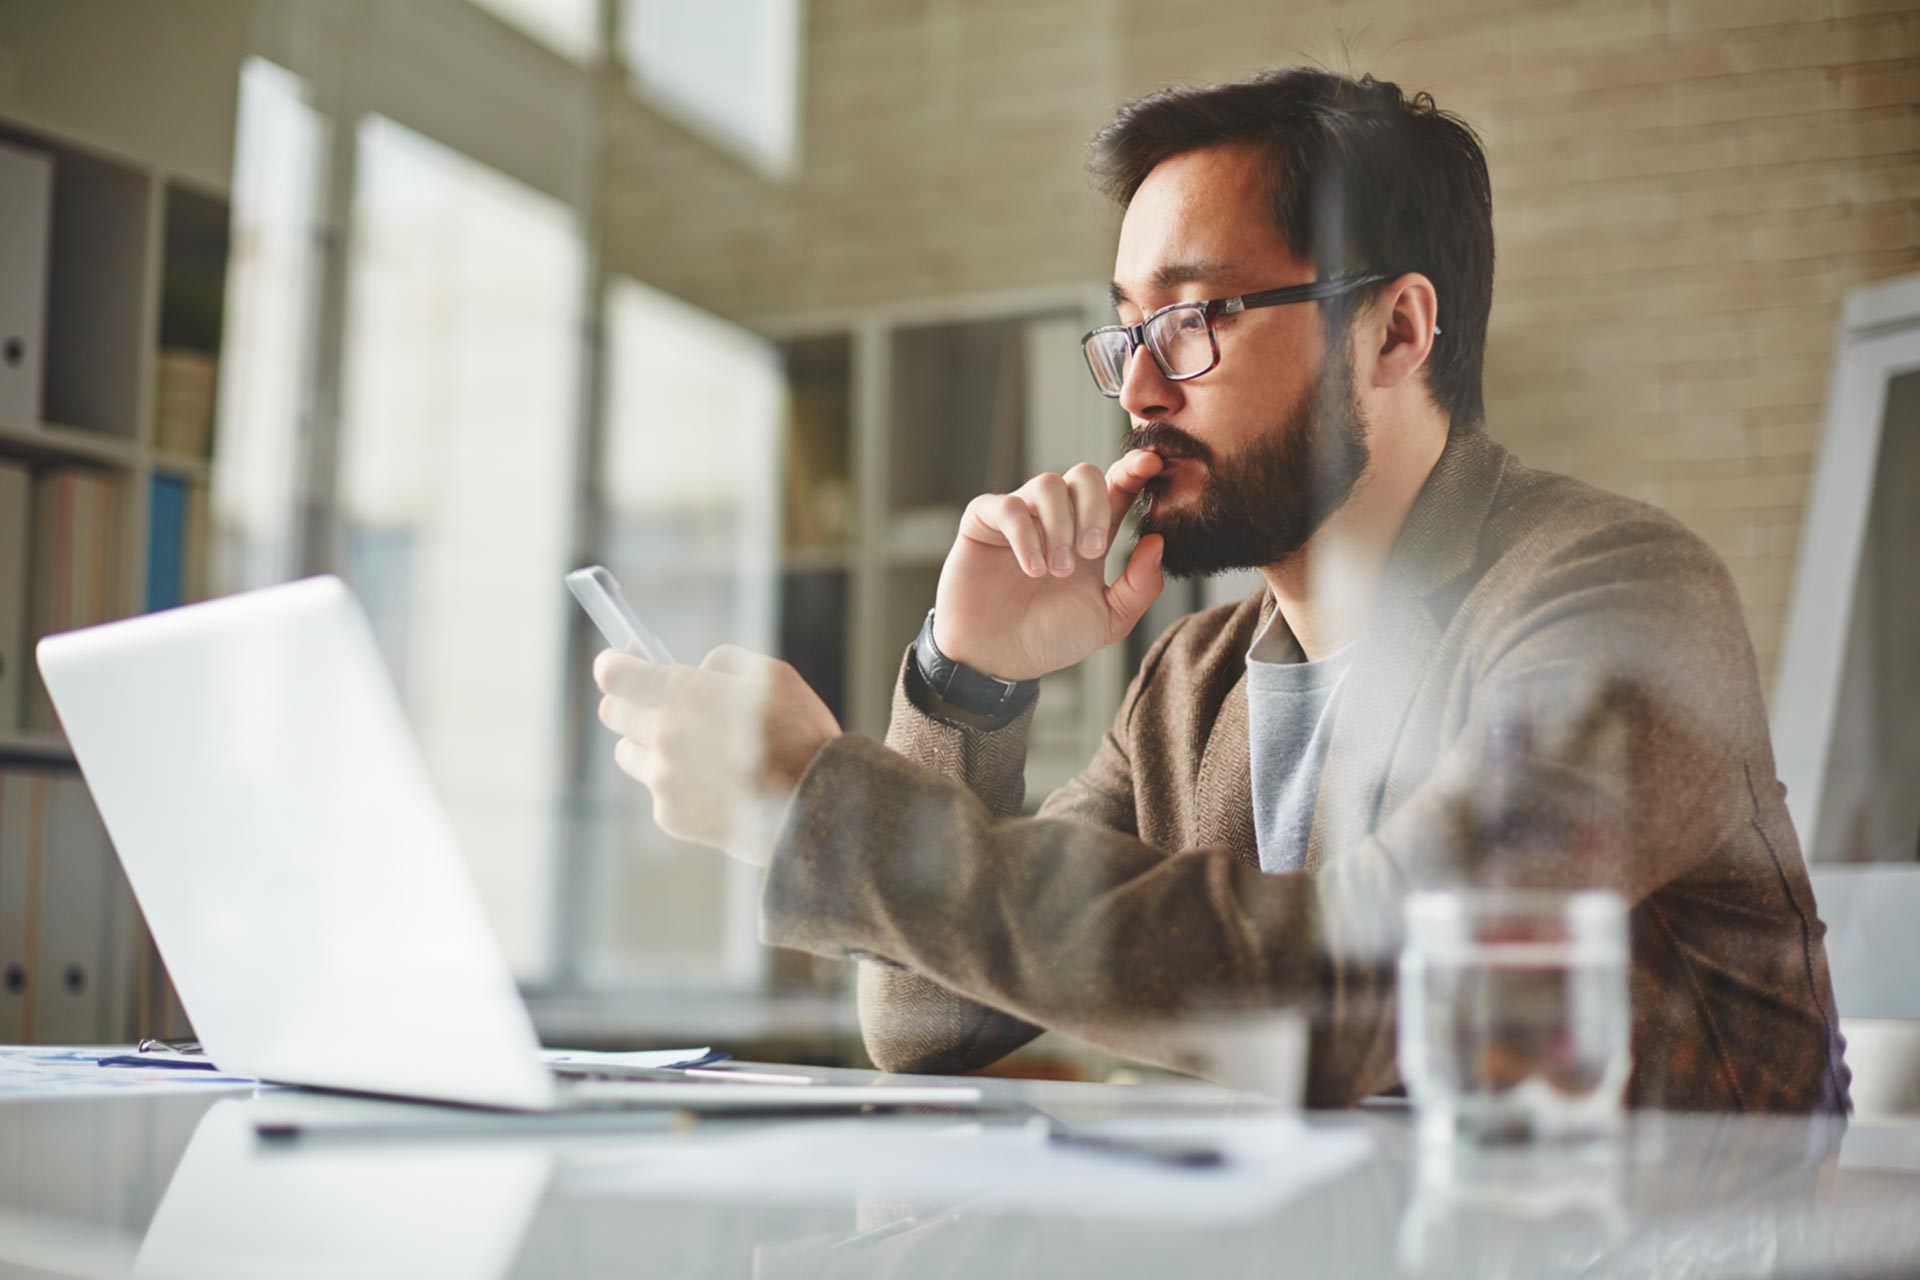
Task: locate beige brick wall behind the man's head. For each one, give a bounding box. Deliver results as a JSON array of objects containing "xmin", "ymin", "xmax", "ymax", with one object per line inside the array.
[{"xmin": 603, "ymin": 0, "xmax": 1920, "ymax": 679}]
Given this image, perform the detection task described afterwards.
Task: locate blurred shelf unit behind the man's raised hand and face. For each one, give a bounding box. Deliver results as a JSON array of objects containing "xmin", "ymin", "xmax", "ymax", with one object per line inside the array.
[{"xmin": 760, "ymin": 288, "xmax": 1127, "ymax": 808}]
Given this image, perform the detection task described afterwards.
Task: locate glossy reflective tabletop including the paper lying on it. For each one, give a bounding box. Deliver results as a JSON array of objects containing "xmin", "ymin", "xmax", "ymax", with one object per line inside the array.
[{"xmin": 0, "ymin": 1067, "xmax": 1920, "ymax": 1280}]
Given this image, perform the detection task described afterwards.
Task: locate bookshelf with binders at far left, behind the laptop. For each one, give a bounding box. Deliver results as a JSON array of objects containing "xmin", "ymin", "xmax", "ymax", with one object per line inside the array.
[{"xmin": 0, "ymin": 115, "xmax": 228, "ymax": 1042}]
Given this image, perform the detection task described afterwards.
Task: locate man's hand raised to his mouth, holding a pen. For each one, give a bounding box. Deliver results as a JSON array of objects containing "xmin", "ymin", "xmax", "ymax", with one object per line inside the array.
[{"xmin": 933, "ymin": 449, "xmax": 1165, "ymax": 679}]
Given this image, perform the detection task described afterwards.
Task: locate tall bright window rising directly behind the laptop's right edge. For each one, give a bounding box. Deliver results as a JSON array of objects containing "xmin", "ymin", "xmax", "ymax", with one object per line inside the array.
[{"xmin": 338, "ymin": 117, "xmax": 586, "ymax": 979}]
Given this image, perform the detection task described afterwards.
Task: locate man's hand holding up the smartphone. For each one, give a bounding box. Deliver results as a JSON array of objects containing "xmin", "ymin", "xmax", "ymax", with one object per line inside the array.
[{"xmin": 593, "ymin": 645, "xmax": 841, "ymax": 865}]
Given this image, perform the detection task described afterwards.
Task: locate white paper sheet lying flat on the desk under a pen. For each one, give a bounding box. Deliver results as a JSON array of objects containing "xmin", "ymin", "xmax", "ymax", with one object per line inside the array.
[{"xmin": 566, "ymin": 1115, "xmax": 1373, "ymax": 1219}]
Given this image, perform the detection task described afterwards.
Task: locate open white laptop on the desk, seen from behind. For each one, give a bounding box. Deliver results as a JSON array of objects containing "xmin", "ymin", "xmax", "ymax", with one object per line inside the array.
[{"xmin": 38, "ymin": 578, "xmax": 979, "ymax": 1111}]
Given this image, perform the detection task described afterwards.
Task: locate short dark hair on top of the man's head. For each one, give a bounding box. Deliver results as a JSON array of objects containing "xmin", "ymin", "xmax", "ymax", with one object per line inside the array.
[{"xmin": 1087, "ymin": 67, "xmax": 1494, "ymax": 430}]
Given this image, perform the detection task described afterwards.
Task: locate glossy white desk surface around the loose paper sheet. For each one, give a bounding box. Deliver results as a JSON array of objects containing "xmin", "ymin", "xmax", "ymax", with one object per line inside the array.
[{"xmin": 0, "ymin": 1050, "xmax": 1920, "ymax": 1280}]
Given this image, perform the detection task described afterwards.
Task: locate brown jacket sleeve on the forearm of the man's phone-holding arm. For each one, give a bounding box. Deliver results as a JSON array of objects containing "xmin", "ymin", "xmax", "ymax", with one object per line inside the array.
[{"xmin": 762, "ymin": 739, "xmax": 1394, "ymax": 1103}]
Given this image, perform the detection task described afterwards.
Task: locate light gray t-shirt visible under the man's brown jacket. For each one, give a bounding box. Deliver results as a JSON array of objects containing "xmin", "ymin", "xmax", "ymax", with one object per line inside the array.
[{"xmin": 1246, "ymin": 614, "xmax": 1354, "ymax": 871}]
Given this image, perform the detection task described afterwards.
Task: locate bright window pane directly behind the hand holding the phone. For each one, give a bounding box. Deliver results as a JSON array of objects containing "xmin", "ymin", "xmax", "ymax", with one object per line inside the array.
[{"xmin": 576, "ymin": 278, "xmax": 785, "ymax": 986}]
